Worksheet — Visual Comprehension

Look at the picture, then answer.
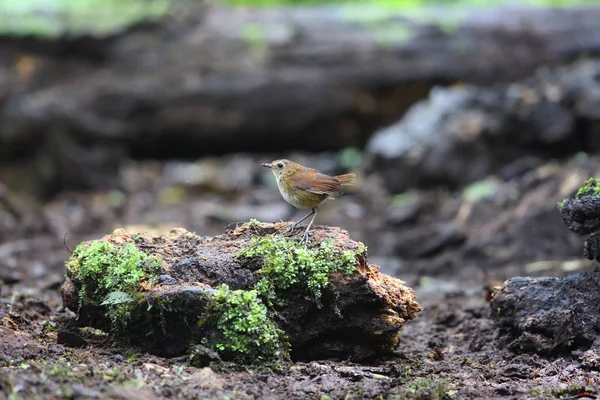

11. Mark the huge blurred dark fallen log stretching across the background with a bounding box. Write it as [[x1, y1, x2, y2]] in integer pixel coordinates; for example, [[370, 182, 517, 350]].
[[0, 5, 600, 195]]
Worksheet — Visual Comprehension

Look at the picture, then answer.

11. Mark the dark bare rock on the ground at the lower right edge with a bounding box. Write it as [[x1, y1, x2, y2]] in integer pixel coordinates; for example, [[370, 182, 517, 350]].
[[490, 268, 600, 355]]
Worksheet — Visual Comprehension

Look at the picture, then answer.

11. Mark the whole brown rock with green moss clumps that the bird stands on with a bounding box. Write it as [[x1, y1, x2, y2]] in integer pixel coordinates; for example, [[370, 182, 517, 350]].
[[62, 221, 421, 363]]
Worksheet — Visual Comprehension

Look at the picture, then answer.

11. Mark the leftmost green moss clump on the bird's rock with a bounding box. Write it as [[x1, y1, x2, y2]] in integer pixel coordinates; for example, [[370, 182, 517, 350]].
[[66, 240, 161, 328]]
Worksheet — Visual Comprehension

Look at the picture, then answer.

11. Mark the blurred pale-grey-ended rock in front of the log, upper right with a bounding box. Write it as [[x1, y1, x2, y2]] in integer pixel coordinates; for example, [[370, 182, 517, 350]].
[[366, 62, 600, 192]]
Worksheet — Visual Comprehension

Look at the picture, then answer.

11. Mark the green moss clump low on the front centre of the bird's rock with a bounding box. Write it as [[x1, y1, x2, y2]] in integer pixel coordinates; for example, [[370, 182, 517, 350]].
[[207, 284, 287, 362]]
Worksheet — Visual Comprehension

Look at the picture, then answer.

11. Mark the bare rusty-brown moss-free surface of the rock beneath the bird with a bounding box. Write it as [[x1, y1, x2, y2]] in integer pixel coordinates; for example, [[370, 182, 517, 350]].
[[62, 222, 421, 359]]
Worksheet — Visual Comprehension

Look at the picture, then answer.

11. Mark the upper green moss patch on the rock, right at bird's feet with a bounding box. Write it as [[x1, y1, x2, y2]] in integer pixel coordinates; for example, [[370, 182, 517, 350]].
[[237, 235, 365, 302]]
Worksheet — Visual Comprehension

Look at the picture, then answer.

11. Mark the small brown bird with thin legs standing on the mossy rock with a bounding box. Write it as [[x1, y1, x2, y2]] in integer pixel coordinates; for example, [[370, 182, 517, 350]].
[[261, 160, 356, 243]]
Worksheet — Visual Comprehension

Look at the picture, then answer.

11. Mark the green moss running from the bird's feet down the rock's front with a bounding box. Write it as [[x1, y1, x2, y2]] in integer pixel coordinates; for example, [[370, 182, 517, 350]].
[[216, 228, 366, 360]]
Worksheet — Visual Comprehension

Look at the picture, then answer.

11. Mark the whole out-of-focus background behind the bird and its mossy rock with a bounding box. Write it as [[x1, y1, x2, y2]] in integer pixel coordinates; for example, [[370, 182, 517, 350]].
[[0, 0, 600, 293]]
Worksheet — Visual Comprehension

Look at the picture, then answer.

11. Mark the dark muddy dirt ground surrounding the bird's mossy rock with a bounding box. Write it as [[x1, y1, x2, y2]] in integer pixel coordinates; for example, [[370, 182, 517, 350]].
[[0, 155, 600, 400]]
